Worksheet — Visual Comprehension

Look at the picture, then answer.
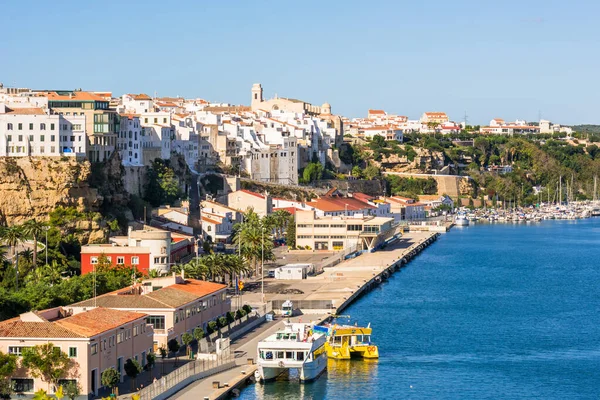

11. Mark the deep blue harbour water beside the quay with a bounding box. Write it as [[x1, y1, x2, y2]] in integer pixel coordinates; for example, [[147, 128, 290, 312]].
[[241, 218, 600, 400]]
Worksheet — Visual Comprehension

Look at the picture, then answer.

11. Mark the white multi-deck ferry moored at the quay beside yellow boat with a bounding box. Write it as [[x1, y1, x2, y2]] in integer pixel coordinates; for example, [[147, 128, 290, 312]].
[[256, 323, 327, 382]]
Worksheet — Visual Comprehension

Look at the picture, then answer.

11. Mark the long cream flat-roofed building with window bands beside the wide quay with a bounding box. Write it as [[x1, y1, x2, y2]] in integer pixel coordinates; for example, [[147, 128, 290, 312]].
[[296, 210, 397, 251]]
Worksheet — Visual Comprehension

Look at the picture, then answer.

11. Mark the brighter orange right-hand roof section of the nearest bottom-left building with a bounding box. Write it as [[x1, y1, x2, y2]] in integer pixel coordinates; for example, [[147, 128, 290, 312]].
[[54, 307, 146, 337]]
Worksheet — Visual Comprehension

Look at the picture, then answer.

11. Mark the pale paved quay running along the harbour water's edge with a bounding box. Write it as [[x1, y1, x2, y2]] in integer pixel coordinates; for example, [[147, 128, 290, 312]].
[[171, 232, 437, 400]]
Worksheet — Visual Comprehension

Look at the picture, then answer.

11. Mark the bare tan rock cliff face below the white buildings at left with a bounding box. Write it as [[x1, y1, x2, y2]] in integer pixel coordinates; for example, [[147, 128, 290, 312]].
[[0, 157, 103, 224]]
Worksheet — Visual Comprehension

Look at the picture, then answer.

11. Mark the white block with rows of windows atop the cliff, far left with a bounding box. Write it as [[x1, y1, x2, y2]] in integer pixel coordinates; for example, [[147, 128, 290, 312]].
[[0, 104, 87, 158]]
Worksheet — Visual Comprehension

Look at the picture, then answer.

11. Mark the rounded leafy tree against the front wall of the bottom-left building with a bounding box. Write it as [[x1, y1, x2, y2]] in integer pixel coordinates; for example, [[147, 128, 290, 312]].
[[21, 343, 72, 385]]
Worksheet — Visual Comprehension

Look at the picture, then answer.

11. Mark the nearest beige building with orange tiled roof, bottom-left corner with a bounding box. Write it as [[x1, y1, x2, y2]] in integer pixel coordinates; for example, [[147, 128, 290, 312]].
[[0, 307, 153, 399]]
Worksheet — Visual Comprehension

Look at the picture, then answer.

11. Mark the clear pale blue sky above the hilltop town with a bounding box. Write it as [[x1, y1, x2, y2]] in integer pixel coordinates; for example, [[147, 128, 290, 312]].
[[0, 0, 600, 124]]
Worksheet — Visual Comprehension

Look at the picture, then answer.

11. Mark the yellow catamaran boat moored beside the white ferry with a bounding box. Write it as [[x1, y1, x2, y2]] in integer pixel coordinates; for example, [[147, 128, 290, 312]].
[[315, 324, 379, 360]]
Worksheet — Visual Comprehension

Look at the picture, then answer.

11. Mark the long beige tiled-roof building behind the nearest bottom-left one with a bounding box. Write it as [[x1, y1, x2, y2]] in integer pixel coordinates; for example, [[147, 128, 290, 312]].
[[68, 274, 231, 351]]
